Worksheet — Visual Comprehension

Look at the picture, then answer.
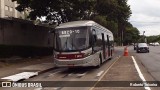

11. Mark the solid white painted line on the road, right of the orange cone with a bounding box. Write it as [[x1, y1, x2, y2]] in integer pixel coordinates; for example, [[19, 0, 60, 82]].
[[132, 56, 151, 90]]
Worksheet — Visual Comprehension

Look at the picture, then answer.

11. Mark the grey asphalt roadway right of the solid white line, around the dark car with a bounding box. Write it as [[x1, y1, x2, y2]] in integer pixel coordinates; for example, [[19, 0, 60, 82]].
[[129, 46, 160, 81]]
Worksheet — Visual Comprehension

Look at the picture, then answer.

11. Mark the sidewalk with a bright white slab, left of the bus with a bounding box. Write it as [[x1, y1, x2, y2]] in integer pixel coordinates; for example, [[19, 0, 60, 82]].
[[0, 56, 54, 81]]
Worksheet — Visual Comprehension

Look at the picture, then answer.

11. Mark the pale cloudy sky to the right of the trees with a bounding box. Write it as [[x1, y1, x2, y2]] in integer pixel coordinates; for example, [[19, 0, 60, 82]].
[[128, 0, 160, 36]]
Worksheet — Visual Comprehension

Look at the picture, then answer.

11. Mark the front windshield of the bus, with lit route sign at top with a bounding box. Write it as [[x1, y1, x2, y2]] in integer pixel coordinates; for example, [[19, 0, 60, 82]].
[[54, 27, 89, 51]]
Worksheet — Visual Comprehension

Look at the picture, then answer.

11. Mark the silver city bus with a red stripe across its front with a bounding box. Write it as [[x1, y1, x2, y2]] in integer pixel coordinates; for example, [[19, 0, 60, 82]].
[[53, 21, 114, 67]]
